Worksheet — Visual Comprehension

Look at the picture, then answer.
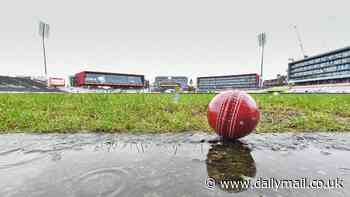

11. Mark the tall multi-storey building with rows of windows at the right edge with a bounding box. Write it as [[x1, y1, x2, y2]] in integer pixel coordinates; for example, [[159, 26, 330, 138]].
[[288, 47, 350, 85]]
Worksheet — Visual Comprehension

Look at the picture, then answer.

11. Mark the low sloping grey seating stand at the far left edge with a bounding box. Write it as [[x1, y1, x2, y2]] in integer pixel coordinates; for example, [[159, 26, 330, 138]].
[[0, 76, 61, 92]]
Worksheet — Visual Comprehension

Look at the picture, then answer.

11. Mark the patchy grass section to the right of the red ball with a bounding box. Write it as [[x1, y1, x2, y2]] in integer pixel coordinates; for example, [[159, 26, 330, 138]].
[[253, 94, 350, 132]]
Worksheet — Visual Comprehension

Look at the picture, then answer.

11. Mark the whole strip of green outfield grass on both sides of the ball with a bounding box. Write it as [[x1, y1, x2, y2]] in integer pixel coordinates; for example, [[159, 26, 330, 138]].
[[0, 93, 350, 133]]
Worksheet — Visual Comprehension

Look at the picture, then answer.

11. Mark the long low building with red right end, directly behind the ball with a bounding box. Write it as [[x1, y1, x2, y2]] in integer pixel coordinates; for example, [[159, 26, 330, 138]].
[[197, 73, 260, 92]]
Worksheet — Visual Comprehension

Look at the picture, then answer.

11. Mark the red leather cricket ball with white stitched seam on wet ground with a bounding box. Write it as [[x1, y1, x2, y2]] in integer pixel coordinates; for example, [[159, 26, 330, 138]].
[[208, 90, 260, 139]]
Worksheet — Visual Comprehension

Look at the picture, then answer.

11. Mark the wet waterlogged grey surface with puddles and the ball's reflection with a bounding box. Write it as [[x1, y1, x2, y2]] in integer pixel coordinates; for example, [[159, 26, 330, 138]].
[[0, 133, 350, 197]]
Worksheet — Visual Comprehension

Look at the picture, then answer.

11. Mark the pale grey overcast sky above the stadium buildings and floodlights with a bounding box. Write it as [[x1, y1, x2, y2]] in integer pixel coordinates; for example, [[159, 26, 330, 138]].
[[0, 0, 350, 79]]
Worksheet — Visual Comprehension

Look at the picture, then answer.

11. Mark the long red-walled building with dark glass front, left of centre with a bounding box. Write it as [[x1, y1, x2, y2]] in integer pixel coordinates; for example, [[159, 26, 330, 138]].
[[74, 71, 145, 89]]
